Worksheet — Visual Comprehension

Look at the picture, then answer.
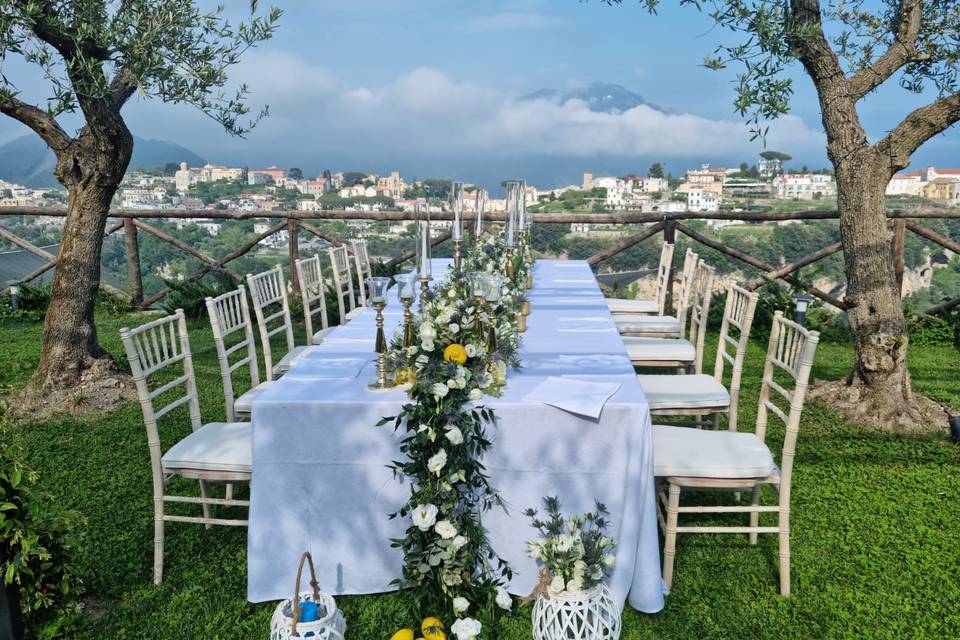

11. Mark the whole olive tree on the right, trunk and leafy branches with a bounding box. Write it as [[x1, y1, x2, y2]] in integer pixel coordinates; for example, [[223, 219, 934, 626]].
[[604, 0, 960, 428]]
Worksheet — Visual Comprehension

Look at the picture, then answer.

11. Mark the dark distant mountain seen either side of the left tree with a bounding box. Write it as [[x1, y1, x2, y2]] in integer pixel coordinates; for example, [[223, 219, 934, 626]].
[[0, 133, 206, 188]]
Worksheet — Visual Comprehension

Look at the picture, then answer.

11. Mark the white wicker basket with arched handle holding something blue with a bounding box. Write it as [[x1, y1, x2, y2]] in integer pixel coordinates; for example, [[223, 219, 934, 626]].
[[270, 551, 347, 640]]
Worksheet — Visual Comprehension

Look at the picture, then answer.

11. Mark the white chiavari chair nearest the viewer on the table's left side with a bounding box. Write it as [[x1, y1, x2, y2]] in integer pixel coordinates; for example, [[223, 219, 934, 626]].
[[120, 309, 251, 584]]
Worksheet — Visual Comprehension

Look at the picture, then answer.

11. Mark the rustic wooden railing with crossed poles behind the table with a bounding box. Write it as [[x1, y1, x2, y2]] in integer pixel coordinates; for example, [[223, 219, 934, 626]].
[[0, 207, 960, 315]]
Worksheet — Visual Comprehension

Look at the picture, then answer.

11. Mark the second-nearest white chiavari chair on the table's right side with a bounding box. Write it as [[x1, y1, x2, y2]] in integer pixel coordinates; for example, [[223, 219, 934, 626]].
[[637, 285, 757, 431]]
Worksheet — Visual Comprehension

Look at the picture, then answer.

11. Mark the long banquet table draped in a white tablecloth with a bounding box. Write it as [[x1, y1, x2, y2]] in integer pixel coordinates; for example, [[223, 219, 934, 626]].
[[247, 260, 664, 613]]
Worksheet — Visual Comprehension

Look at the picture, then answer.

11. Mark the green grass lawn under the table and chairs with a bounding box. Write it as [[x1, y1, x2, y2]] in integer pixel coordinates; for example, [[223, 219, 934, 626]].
[[0, 316, 960, 640]]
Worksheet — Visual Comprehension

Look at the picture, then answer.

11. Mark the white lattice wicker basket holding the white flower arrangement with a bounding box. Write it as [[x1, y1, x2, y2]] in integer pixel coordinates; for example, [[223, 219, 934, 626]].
[[533, 584, 620, 640]]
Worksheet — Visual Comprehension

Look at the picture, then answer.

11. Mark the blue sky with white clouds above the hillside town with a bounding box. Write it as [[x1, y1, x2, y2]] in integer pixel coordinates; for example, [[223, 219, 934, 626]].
[[0, 0, 960, 187]]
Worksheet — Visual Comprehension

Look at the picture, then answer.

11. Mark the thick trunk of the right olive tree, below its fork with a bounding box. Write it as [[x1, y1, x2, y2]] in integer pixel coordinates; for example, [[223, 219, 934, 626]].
[[835, 158, 921, 429]]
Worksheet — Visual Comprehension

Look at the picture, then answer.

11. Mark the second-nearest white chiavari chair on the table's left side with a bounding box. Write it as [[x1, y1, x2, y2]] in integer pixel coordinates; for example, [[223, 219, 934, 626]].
[[206, 285, 273, 421]]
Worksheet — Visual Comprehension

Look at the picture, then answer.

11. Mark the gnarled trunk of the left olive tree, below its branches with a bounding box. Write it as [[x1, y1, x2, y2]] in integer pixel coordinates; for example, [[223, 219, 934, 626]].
[[27, 131, 133, 398]]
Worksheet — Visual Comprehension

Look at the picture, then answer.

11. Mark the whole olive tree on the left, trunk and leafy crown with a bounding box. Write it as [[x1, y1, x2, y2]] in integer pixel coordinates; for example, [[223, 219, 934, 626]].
[[0, 0, 280, 397]]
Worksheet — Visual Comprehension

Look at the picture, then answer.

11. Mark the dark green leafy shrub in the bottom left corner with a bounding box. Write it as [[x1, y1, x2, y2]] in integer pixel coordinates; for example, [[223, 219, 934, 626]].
[[0, 420, 83, 629]]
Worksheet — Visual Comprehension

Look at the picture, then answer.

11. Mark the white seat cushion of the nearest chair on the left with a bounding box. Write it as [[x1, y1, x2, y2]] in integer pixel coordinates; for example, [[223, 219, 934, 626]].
[[161, 422, 251, 473]]
